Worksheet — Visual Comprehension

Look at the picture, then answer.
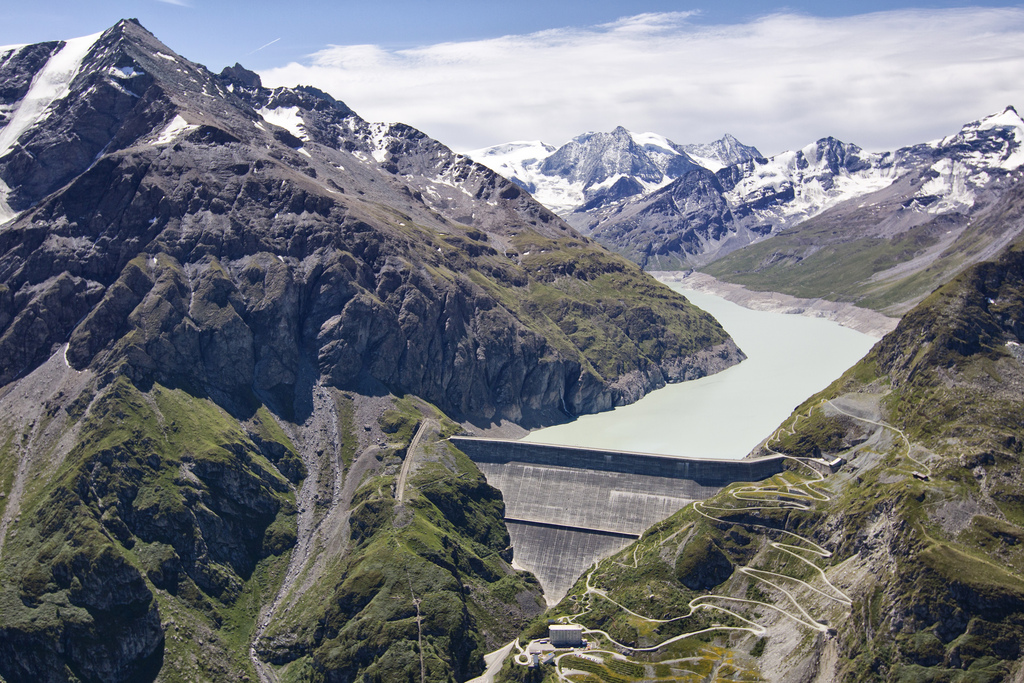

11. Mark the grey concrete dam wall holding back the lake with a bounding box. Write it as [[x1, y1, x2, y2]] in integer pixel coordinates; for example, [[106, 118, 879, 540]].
[[452, 436, 784, 604]]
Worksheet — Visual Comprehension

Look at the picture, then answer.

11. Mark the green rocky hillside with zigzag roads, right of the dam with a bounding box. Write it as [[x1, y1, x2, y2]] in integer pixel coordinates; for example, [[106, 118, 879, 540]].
[[502, 222, 1024, 682]]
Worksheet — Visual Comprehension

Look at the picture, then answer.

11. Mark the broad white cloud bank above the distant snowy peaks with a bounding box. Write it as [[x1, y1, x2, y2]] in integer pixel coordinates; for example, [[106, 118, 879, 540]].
[[261, 8, 1024, 154]]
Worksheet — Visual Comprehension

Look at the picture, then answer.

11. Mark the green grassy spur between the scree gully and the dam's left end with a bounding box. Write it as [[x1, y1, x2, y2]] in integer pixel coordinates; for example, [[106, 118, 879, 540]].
[[265, 397, 541, 681]]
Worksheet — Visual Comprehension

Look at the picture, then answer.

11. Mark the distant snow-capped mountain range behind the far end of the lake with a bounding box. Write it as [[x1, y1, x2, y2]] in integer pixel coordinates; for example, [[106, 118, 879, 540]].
[[470, 106, 1024, 314]]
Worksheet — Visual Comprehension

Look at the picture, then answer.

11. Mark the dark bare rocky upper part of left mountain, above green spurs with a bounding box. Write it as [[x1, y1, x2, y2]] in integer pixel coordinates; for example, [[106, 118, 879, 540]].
[[0, 23, 733, 428]]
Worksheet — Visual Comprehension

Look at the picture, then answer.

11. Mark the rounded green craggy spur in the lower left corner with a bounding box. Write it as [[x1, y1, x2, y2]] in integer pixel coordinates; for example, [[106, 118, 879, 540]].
[[0, 379, 295, 680]]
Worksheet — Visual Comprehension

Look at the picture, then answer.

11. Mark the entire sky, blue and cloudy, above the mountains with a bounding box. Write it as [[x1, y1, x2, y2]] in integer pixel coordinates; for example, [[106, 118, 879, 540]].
[[6, 0, 1024, 154]]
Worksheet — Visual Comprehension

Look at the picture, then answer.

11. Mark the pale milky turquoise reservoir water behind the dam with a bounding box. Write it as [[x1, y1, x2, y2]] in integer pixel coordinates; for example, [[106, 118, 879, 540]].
[[523, 286, 877, 459]]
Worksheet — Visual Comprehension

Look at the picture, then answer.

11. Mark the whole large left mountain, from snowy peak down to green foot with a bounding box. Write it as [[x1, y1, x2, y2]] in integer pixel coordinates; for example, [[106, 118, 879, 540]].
[[0, 20, 741, 682]]
